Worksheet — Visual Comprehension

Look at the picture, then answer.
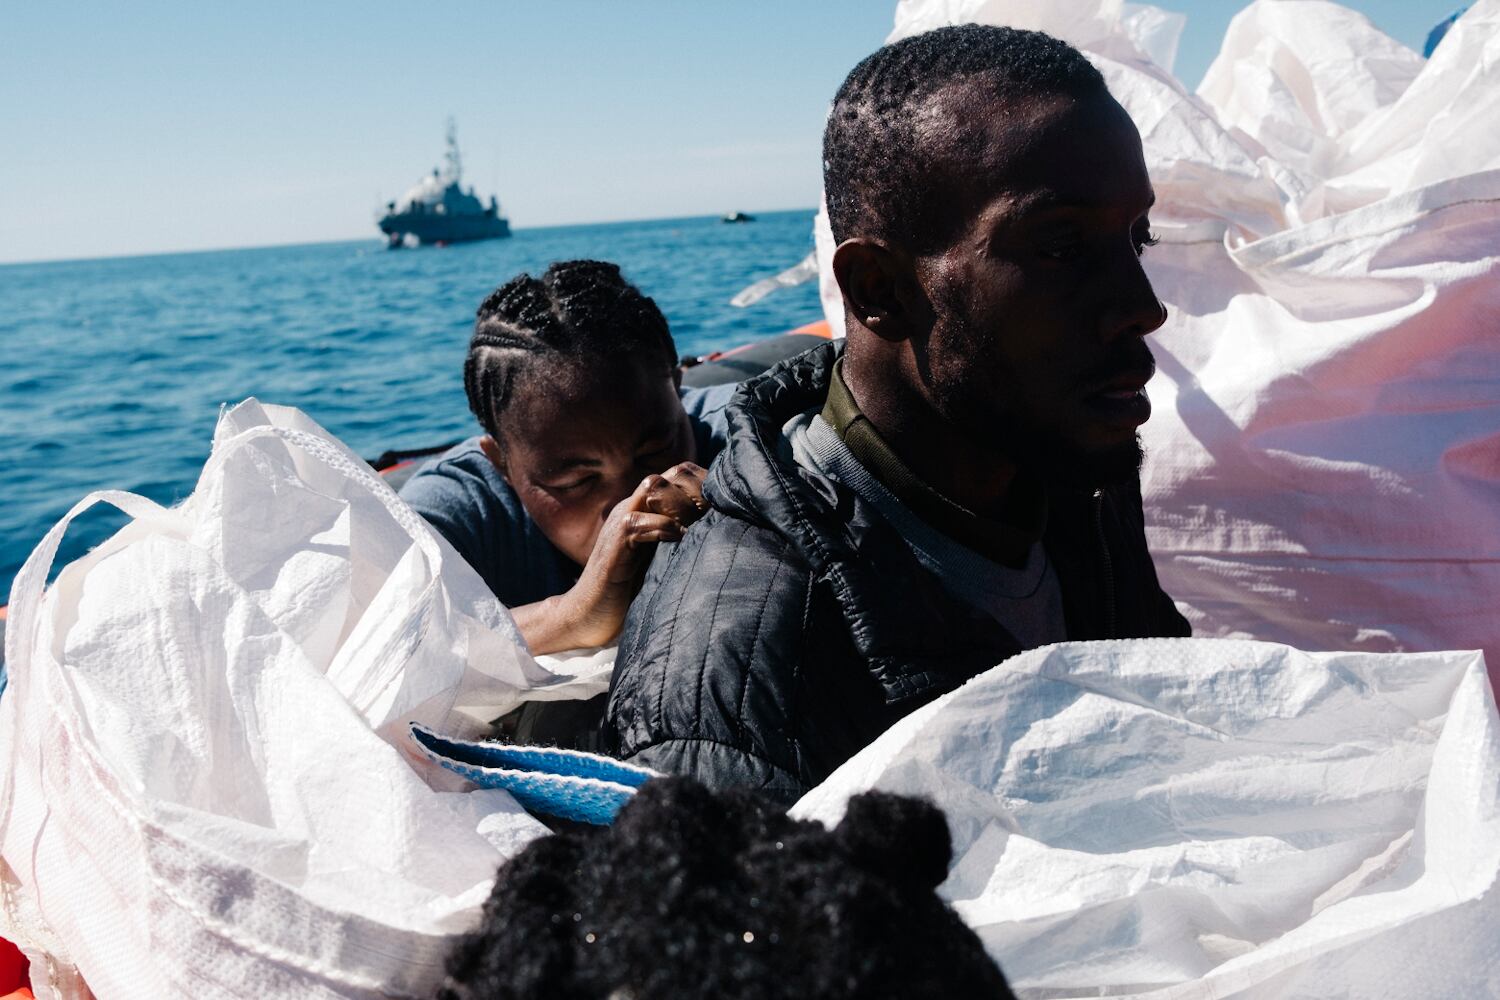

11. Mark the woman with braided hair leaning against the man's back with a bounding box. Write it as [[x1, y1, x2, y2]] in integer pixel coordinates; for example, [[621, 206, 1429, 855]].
[[401, 261, 734, 654]]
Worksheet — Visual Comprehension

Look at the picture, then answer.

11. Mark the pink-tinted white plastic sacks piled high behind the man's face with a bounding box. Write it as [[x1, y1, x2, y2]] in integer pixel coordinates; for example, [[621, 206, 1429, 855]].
[[819, 0, 1500, 692]]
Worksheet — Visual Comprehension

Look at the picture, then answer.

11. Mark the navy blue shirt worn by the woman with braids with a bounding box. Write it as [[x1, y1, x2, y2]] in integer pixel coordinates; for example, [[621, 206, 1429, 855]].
[[401, 384, 738, 607]]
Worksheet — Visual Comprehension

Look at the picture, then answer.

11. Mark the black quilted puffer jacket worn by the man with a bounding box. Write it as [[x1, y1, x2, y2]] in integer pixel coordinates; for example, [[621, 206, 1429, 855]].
[[603, 345, 1188, 802]]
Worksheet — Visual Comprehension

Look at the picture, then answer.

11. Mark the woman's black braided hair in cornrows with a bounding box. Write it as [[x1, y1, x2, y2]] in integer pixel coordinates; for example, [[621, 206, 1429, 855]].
[[464, 261, 677, 441]]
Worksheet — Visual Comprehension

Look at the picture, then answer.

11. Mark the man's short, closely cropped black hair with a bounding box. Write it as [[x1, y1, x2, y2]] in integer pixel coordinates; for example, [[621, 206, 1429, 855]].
[[824, 24, 1109, 250]]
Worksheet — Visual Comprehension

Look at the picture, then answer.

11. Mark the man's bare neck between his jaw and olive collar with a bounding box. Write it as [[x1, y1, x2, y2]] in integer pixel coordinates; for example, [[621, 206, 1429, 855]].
[[842, 347, 1017, 517]]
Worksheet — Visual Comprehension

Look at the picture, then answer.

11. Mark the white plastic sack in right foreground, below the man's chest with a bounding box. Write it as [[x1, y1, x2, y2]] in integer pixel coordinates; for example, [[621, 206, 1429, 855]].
[[792, 639, 1500, 1000]]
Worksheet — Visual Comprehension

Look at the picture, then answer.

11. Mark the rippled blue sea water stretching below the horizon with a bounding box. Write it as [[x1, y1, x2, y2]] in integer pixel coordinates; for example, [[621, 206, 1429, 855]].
[[0, 211, 821, 590]]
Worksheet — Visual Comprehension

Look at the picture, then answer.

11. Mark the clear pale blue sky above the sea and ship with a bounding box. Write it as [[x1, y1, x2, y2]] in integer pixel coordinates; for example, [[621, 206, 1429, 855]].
[[0, 0, 1458, 261]]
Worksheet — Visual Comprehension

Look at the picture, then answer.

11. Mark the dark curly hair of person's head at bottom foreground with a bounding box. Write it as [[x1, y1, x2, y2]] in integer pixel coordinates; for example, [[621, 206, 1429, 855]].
[[440, 778, 1013, 1000]]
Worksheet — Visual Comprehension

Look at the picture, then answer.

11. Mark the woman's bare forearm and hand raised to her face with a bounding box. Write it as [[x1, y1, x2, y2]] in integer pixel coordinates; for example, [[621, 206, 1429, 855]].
[[512, 462, 708, 654]]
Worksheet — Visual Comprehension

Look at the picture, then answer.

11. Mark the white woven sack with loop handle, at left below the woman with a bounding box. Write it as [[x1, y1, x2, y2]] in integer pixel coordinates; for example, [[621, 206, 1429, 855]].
[[0, 400, 558, 1000]]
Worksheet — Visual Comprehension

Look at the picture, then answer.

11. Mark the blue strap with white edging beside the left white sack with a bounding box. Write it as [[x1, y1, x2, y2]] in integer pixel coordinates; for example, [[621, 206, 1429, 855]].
[[411, 723, 660, 826]]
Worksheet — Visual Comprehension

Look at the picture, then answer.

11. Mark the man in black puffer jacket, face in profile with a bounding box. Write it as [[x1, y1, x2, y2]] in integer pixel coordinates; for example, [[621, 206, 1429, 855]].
[[603, 25, 1188, 801]]
